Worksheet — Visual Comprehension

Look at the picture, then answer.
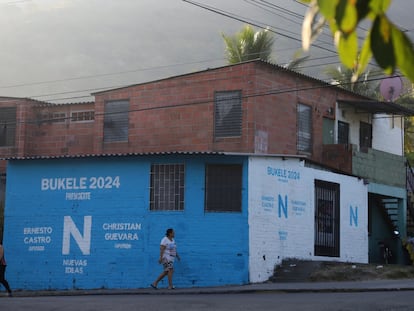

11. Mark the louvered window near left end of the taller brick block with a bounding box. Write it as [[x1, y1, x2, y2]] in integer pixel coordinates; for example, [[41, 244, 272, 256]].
[[104, 100, 129, 142]]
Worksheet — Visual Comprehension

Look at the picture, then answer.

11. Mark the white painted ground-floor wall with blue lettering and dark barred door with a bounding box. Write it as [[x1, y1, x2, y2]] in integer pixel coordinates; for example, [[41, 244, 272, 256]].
[[248, 157, 368, 282]]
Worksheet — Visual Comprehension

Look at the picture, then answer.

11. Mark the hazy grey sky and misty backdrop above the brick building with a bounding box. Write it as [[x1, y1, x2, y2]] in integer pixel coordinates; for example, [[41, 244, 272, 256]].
[[0, 0, 414, 102]]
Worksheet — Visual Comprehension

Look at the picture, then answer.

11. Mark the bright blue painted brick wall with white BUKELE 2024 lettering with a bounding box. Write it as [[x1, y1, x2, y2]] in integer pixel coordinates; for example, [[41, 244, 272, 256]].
[[4, 156, 249, 290]]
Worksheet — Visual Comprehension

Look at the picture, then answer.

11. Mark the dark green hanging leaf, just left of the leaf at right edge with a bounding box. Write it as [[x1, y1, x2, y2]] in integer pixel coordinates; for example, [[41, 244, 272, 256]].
[[370, 15, 396, 74]]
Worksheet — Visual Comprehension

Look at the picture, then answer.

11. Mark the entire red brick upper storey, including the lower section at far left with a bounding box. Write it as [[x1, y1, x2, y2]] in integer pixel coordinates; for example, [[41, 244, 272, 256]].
[[0, 61, 382, 169]]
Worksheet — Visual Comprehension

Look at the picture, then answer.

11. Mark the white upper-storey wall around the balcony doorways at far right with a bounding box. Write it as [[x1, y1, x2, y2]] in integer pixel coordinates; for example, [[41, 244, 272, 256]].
[[335, 107, 404, 156]]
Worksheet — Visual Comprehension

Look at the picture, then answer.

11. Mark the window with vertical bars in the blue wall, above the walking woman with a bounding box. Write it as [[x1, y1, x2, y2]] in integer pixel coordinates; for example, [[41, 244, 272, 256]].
[[150, 164, 184, 211]]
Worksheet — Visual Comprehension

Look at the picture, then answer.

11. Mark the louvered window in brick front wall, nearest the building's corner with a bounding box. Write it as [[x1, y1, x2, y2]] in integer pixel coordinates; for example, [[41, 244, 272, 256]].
[[214, 91, 242, 138]]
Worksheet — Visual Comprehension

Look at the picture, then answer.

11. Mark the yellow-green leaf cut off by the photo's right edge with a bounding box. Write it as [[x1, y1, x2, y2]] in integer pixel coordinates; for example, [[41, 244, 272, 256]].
[[392, 25, 414, 82]]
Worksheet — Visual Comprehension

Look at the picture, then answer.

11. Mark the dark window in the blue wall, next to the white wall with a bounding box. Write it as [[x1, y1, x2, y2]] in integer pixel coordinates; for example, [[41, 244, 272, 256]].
[[205, 164, 242, 212]]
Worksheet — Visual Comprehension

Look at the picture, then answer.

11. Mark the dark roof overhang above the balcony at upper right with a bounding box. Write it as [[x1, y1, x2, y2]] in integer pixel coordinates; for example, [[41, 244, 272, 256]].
[[338, 100, 414, 116]]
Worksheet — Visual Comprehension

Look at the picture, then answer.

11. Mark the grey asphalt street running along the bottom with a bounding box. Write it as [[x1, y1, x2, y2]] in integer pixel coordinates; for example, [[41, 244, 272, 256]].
[[0, 290, 414, 311]]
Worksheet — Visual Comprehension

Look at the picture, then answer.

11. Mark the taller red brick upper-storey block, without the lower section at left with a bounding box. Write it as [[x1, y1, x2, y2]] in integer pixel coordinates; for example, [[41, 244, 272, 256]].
[[94, 62, 362, 161]]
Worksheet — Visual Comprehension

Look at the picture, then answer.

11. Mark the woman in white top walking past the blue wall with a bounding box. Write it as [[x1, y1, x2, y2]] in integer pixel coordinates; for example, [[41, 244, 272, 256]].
[[151, 228, 180, 289]]
